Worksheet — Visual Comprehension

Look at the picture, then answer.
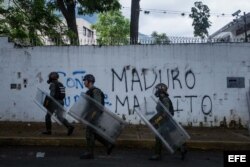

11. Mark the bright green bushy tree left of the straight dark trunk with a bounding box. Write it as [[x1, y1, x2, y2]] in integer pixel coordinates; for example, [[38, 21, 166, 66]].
[[92, 10, 129, 45]]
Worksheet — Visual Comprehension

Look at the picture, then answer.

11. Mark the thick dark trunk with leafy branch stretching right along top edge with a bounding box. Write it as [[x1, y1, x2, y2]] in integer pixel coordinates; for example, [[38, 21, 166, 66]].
[[52, 0, 121, 44]]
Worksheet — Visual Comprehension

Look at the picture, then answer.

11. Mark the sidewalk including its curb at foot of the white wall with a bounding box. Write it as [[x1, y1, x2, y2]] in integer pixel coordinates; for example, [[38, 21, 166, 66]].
[[0, 122, 250, 150]]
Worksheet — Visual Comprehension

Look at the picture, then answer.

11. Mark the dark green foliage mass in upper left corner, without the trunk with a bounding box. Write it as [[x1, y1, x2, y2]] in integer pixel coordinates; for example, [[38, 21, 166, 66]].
[[0, 0, 66, 45]]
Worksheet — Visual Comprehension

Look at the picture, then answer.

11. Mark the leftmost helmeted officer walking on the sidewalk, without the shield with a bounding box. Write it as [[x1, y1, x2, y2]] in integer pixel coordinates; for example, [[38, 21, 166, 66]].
[[42, 72, 74, 136]]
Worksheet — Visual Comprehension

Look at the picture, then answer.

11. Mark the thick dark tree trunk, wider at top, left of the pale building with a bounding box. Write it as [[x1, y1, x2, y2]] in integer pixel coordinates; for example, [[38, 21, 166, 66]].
[[57, 0, 79, 45]]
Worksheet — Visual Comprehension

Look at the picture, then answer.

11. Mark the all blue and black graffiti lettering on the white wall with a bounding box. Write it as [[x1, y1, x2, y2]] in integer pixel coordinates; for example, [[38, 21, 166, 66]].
[[55, 67, 212, 118]]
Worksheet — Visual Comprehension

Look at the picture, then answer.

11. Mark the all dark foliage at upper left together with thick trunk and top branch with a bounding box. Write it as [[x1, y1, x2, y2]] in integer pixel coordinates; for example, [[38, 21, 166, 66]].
[[0, 0, 121, 45]]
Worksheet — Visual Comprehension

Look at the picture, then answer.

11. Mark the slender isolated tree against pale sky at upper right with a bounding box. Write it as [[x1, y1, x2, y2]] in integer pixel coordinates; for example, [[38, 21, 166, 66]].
[[189, 1, 211, 38]]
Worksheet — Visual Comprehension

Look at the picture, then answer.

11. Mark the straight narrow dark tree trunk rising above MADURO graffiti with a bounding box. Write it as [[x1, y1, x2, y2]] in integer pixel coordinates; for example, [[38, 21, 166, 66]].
[[130, 0, 140, 44]]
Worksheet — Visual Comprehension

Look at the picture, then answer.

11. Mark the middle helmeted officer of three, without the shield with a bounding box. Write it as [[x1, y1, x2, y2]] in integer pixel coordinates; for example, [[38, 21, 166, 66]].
[[80, 74, 114, 159]]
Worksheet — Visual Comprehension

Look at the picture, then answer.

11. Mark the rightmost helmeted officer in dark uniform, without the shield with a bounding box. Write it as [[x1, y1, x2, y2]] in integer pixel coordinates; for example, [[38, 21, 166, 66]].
[[149, 83, 187, 161]]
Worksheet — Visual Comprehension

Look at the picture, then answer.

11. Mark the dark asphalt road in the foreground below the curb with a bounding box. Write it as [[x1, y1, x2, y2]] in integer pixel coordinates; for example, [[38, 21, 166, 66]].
[[0, 146, 223, 167]]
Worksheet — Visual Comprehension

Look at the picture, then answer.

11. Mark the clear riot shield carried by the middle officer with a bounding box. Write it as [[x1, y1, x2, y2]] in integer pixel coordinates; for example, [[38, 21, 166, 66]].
[[68, 93, 126, 144]]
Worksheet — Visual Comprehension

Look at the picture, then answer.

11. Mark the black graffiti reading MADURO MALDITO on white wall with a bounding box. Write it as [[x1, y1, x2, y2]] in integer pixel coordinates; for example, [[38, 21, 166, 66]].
[[111, 67, 212, 115]]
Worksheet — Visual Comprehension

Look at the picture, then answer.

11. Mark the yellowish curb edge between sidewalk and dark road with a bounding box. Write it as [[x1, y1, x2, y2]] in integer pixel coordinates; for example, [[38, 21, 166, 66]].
[[0, 137, 250, 151]]
